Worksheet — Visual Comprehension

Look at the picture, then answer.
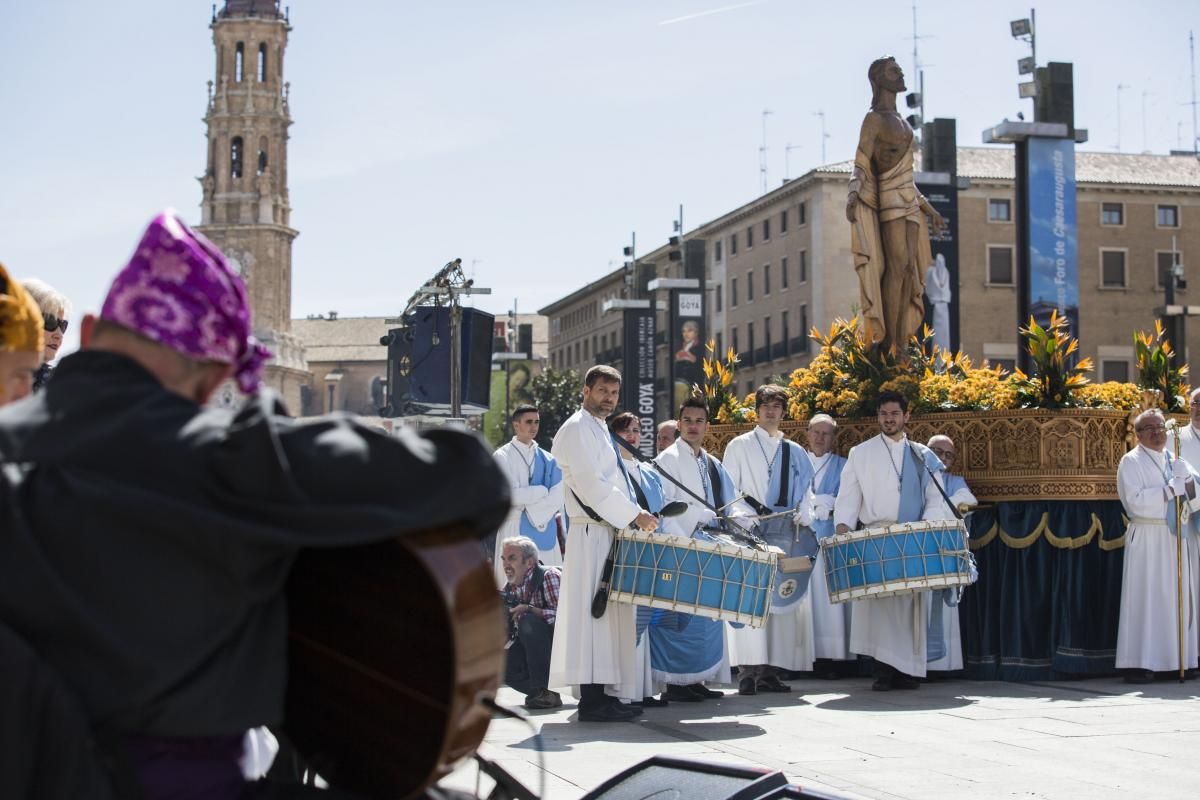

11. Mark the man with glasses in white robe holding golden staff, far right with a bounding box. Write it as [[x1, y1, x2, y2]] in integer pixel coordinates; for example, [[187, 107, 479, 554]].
[[1116, 409, 1200, 684]]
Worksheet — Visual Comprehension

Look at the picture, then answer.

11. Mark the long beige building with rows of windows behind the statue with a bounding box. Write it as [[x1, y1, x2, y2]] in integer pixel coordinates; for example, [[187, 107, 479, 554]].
[[541, 148, 1200, 416]]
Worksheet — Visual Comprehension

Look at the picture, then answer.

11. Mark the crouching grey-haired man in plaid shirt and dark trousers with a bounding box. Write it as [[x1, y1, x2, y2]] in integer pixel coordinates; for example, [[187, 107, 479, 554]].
[[500, 536, 563, 709]]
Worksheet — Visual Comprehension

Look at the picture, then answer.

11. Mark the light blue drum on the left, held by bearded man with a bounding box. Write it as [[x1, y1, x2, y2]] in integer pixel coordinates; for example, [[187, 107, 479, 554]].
[[608, 529, 776, 627]]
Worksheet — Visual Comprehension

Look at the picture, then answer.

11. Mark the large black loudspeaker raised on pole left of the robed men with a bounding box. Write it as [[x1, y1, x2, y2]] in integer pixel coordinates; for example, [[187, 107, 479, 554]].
[[380, 306, 496, 416]]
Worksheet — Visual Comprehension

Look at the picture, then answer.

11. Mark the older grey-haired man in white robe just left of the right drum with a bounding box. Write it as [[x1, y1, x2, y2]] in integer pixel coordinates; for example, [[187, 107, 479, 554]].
[[808, 414, 854, 680]]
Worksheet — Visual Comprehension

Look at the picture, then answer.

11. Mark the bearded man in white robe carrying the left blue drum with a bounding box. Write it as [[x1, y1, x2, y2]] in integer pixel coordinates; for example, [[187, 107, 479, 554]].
[[550, 365, 659, 722]]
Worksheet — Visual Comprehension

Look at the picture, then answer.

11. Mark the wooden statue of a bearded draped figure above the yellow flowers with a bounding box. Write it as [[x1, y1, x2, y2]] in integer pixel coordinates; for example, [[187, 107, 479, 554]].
[[846, 55, 944, 357]]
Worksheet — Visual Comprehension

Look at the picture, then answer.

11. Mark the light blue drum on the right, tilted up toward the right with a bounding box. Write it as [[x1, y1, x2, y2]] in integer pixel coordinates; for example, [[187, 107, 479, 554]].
[[821, 519, 976, 603]]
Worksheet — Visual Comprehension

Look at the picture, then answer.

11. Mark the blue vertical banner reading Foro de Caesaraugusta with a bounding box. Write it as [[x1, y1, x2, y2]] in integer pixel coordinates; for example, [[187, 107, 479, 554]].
[[1021, 137, 1079, 338]]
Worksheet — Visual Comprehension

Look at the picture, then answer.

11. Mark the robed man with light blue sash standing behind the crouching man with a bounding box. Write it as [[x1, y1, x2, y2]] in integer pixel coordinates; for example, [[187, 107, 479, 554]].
[[492, 403, 563, 589]]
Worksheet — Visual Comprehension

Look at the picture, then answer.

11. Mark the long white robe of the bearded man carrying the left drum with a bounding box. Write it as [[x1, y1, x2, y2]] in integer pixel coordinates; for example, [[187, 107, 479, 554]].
[[550, 409, 643, 699]]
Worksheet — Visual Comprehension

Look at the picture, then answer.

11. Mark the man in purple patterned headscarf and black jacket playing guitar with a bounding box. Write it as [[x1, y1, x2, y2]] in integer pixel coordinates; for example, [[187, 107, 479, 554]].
[[0, 212, 509, 800]]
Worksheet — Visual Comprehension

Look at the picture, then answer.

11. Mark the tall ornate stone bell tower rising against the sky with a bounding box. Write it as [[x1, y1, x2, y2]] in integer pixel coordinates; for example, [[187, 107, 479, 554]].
[[197, 0, 310, 402]]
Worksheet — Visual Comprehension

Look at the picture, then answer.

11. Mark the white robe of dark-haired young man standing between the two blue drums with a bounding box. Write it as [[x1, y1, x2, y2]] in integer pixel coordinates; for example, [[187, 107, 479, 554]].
[[722, 426, 814, 672]]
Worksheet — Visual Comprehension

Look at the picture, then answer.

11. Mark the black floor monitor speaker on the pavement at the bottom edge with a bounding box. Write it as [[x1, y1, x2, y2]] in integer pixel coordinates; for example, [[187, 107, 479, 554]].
[[583, 756, 787, 800]]
